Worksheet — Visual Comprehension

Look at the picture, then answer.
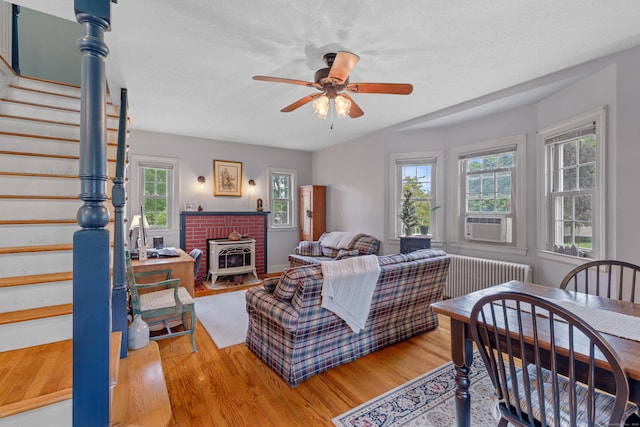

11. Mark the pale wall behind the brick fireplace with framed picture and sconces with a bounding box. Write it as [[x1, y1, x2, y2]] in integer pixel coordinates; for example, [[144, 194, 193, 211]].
[[127, 129, 312, 272]]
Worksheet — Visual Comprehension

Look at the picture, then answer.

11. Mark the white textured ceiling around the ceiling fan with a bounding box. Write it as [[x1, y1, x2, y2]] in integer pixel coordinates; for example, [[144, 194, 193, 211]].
[[15, 0, 640, 151]]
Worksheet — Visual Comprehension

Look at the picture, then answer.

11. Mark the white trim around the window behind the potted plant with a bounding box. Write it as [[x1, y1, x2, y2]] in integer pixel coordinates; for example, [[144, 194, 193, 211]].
[[386, 151, 446, 243]]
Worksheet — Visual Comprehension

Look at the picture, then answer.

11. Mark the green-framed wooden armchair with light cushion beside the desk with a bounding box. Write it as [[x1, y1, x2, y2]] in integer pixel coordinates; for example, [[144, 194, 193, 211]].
[[126, 252, 197, 352]]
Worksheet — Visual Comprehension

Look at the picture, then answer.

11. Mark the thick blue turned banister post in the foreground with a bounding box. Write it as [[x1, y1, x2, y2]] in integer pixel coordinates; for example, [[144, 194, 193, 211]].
[[72, 0, 111, 427]]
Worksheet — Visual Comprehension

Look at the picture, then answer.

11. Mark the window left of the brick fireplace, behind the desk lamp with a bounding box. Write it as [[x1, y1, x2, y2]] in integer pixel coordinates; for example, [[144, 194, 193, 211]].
[[130, 156, 177, 230]]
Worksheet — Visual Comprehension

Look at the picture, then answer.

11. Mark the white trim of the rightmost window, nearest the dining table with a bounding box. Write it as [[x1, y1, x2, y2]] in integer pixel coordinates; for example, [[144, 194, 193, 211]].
[[536, 106, 607, 265]]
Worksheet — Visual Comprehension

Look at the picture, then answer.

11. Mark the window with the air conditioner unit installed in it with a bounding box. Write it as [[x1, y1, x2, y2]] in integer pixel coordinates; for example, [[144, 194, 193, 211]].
[[453, 135, 526, 250]]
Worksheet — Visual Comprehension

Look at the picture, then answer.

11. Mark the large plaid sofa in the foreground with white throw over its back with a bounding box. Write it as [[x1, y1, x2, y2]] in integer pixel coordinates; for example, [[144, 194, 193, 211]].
[[246, 249, 449, 386]]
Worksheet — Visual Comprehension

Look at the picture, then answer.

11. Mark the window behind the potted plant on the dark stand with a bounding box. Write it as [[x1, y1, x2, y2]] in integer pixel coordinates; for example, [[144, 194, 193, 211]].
[[390, 153, 444, 238]]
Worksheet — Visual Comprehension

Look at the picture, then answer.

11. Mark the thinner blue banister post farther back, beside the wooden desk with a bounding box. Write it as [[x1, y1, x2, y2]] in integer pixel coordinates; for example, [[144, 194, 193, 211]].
[[111, 89, 128, 358]]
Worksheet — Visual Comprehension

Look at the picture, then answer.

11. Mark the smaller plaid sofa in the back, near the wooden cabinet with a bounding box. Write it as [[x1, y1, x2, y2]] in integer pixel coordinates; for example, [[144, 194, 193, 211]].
[[289, 233, 380, 267]]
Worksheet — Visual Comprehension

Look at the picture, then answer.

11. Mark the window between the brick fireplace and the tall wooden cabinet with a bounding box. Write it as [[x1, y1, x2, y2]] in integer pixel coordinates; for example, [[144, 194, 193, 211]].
[[269, 169, 297, 228]]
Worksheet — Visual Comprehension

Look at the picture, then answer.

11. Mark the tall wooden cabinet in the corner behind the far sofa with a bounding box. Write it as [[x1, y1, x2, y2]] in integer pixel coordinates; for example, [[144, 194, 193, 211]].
[[300, 185, 327, 241]]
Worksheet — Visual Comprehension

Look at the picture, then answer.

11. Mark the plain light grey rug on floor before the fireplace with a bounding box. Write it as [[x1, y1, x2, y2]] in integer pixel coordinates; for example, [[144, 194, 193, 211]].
[[195, 289, 249, 348]]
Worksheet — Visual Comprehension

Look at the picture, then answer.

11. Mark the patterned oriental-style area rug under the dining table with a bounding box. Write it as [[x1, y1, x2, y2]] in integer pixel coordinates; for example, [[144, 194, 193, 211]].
[[332, 352, 498, 427]]
